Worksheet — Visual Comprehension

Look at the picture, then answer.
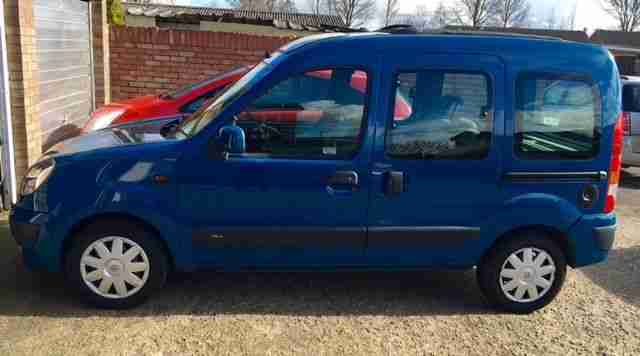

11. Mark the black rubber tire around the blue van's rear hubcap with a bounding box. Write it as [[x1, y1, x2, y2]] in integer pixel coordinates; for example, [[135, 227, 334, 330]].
[[476, 232, 567, 314]]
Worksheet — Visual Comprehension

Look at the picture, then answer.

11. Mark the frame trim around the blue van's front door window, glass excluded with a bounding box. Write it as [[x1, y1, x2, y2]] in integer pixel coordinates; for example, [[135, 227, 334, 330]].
[[221, 65, 374, 162]]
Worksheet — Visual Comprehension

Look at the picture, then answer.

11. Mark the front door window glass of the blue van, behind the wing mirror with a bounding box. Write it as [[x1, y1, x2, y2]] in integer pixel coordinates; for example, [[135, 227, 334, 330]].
[[236, 69, 368, 159]]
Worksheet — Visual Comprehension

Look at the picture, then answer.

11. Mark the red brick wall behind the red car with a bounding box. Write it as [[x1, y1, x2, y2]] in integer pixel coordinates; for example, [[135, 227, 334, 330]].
[[109, 26, 293, 101]]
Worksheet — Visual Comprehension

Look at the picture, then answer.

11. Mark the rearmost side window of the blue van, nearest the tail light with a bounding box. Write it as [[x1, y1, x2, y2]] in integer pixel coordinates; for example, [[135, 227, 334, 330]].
[[515, 73, 601, 159]]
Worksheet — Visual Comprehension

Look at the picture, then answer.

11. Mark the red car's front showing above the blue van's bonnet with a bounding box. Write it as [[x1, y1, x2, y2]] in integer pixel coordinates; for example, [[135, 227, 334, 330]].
[[82, 66, 251, 132]]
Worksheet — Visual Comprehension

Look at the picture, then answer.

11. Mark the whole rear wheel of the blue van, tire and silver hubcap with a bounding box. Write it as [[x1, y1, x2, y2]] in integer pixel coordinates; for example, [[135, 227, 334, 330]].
[[477, 232, 567, 314]]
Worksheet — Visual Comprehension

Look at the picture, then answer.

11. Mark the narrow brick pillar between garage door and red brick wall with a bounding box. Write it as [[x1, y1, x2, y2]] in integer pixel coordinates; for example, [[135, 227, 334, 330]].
[[90, 0, 111, 108]]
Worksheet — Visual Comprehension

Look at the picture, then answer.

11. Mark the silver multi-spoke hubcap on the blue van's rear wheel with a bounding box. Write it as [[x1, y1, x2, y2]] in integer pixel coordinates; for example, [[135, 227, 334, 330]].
[[499, 247, 556, 303]]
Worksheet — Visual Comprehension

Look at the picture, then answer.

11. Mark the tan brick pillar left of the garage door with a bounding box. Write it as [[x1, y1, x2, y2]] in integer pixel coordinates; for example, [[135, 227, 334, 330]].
[[4, 0, 42, 180]]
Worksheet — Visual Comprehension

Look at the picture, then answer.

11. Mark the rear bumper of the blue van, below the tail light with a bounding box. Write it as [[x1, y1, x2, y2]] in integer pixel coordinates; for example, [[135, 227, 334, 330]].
[[568, 214, 617, 268]]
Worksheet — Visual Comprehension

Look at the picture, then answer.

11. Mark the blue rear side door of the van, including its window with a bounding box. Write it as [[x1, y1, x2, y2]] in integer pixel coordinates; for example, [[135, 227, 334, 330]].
[[367, 54, 504, 266]]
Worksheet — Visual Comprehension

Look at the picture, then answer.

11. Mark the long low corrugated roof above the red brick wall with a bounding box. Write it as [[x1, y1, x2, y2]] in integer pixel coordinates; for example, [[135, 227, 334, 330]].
[[124, 2, 344, 31]]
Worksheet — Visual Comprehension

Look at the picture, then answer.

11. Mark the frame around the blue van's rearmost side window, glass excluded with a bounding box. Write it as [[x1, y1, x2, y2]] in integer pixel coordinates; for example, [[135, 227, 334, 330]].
[[510, 71, 604, 162]]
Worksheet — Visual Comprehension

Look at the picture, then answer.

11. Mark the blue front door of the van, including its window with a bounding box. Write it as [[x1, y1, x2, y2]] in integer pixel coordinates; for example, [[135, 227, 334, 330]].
[[179, 66, 372, 268]]
